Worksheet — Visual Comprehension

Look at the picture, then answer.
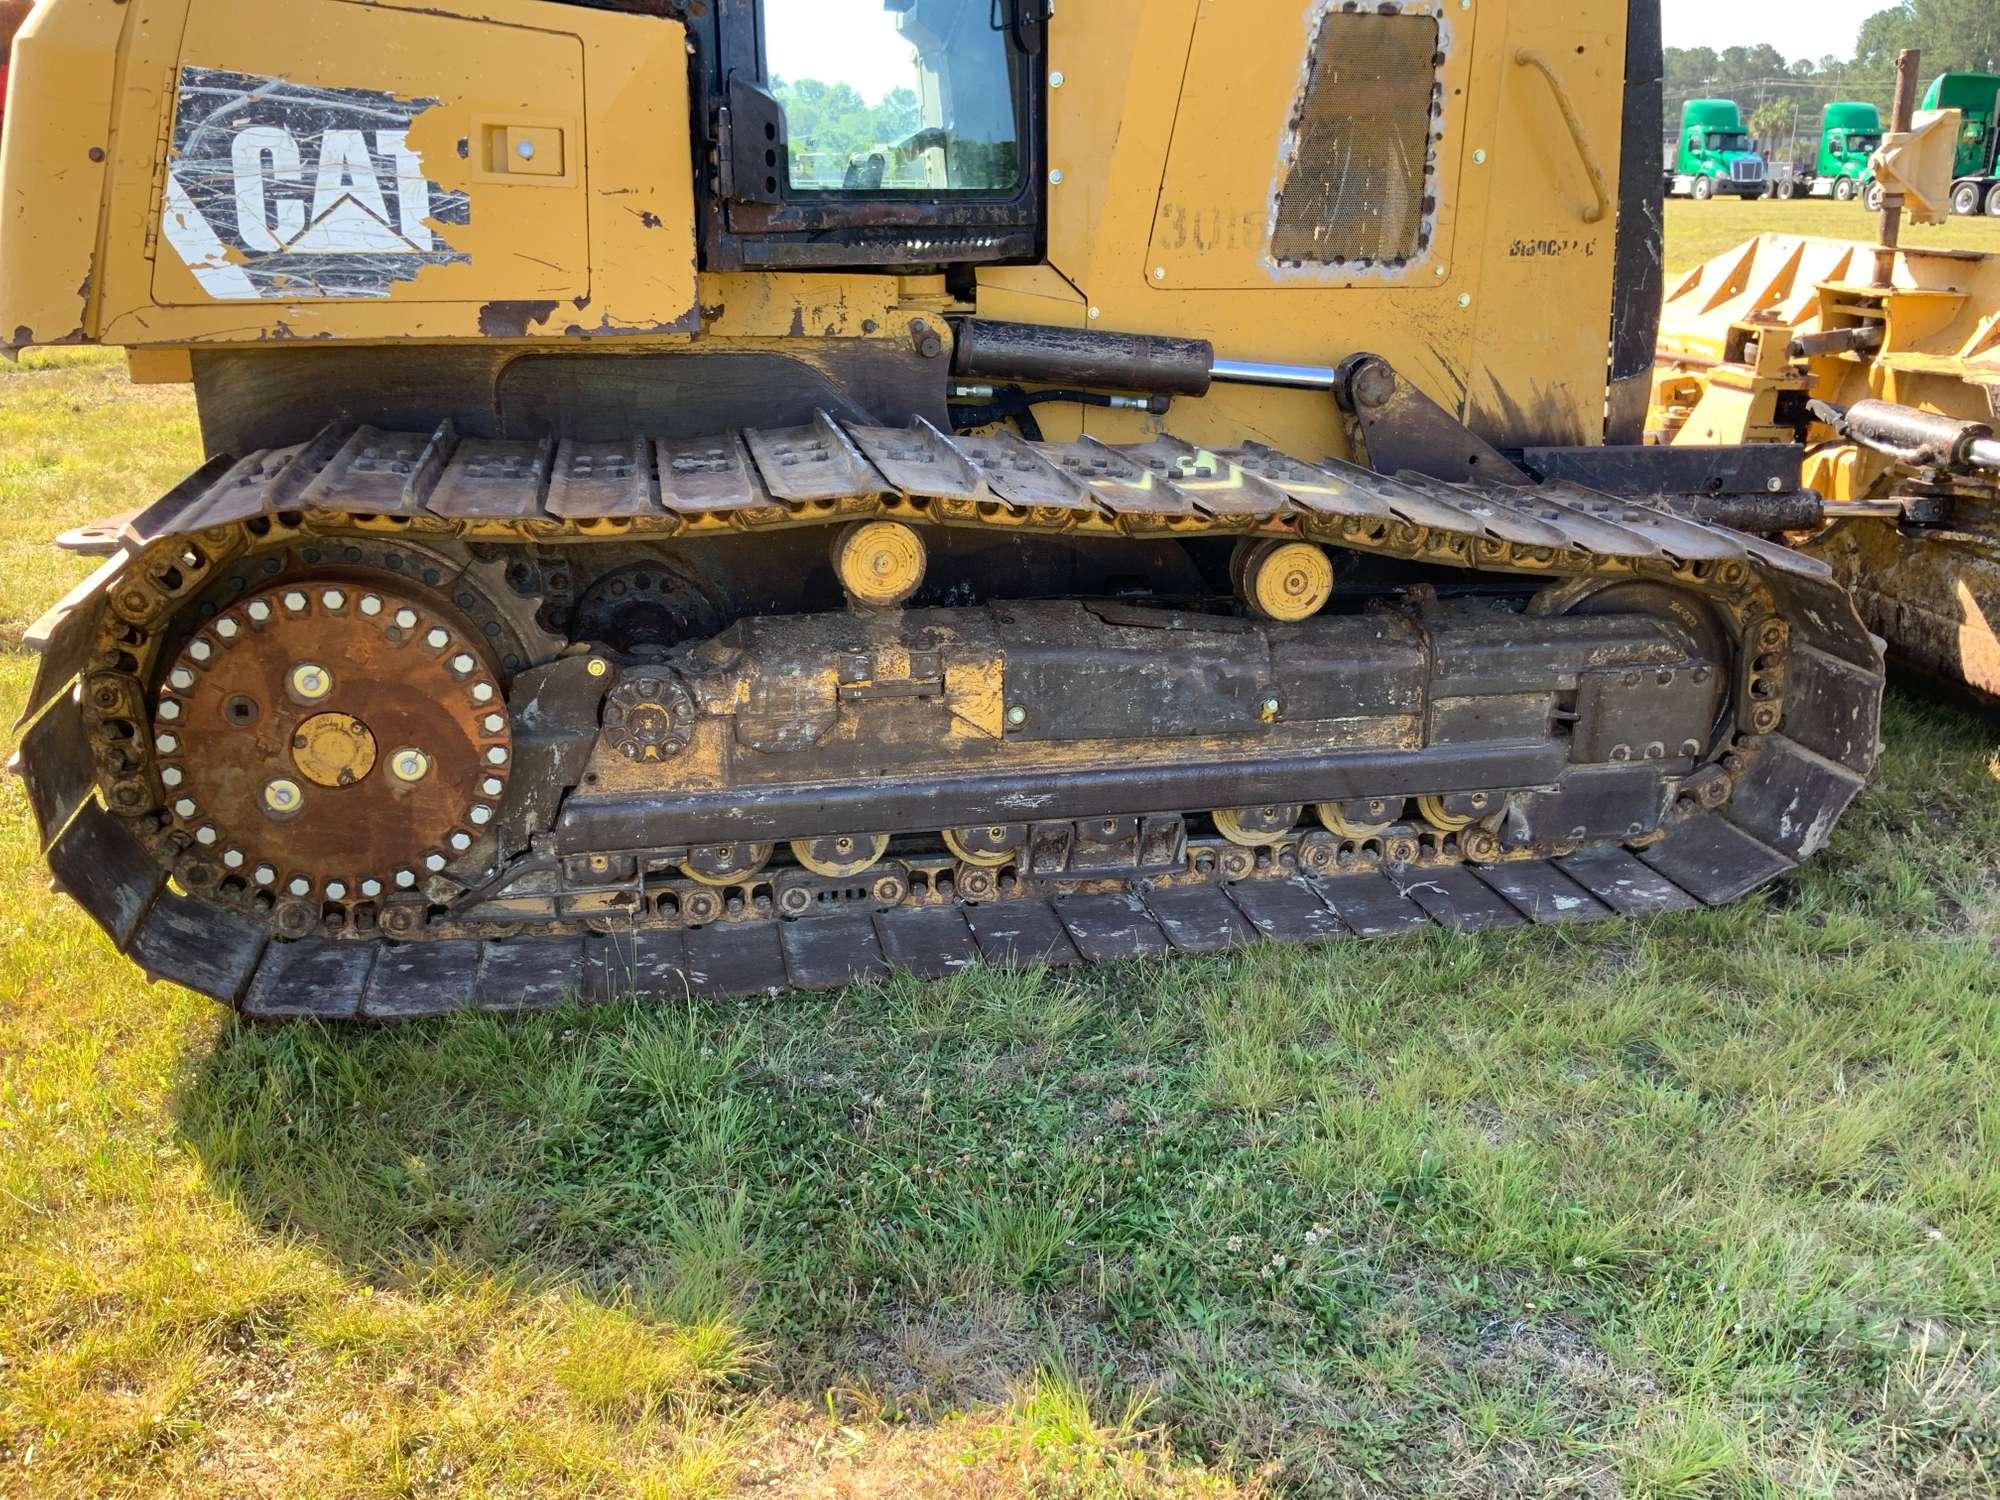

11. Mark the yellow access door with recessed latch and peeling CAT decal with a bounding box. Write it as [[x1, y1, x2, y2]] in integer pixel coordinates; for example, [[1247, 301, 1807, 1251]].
[[152, 0, 590, 308]]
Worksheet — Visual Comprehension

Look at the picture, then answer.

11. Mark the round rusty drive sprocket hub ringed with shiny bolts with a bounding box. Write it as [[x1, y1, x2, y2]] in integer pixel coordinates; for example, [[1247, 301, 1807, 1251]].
[[152, 578, 514, 908]]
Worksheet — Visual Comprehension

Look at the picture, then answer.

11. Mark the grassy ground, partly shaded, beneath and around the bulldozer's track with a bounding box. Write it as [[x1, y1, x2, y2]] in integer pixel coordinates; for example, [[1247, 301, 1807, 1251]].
[[0, 214, 2000, 1498]]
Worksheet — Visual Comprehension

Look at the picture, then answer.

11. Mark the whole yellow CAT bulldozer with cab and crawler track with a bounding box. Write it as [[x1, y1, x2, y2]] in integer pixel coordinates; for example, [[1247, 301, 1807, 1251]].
[[0, 0, 1884, 1018]]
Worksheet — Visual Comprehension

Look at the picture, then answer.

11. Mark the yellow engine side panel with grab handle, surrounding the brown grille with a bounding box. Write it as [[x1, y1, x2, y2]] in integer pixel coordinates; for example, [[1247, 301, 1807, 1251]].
[[1040, 0, 1626, 454]]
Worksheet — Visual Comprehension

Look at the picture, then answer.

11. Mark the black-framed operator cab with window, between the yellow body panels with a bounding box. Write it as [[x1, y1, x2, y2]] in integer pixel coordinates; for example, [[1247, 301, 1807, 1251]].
[[688, 0, 1044, 270]]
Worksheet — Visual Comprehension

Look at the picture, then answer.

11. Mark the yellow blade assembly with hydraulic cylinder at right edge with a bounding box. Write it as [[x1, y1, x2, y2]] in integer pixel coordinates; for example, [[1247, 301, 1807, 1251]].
[[1650, 236, 2000, 708]]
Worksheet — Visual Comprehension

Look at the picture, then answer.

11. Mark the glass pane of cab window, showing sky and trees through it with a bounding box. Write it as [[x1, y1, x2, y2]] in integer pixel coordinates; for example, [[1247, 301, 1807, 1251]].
[[762, 0, 1022, 196]]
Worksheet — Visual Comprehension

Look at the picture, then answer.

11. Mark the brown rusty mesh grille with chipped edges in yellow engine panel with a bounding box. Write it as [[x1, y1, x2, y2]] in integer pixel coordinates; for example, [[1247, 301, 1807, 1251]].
[[1270, 12, 1440, 266]]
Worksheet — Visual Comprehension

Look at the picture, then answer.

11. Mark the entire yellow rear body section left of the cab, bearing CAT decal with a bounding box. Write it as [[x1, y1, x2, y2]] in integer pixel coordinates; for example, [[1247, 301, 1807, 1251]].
[[0, 0, 696, 348]]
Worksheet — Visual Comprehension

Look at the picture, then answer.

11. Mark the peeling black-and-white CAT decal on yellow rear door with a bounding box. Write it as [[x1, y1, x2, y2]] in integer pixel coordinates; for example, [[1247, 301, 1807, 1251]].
[[160, 68, 472, 302]]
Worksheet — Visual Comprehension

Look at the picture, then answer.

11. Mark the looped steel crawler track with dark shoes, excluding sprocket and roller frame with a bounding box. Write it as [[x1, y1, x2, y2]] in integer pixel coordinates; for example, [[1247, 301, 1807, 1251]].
[[18, 416, 1882, 1018]]
